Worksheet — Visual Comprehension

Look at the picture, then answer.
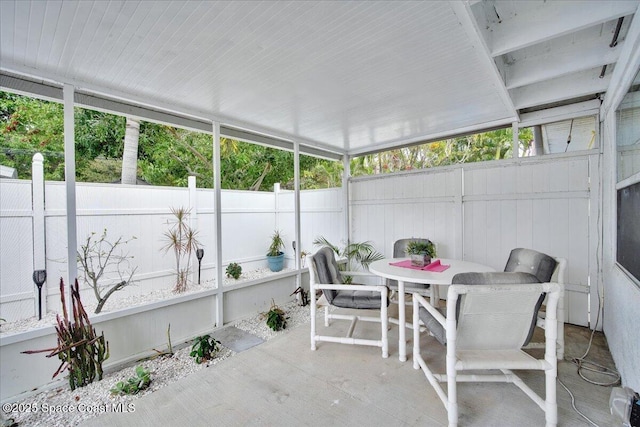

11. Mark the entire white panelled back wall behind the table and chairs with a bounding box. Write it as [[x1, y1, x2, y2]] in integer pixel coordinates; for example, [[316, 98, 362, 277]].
[[350, 154, 599, 325]]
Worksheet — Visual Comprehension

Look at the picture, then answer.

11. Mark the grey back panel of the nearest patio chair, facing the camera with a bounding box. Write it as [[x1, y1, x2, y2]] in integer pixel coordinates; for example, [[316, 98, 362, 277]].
[[447, 283, 557, 350]]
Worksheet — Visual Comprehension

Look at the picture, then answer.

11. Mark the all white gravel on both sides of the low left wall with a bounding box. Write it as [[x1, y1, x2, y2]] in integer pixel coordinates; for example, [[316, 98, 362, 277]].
[[0, 268, 310, 426]]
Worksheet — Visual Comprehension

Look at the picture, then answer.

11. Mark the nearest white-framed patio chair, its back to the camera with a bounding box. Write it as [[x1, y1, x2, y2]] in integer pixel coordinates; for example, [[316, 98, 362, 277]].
[[413, 272, 562, 426]]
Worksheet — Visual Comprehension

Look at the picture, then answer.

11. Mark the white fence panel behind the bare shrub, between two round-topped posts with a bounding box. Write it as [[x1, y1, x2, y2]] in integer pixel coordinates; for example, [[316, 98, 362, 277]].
[[40, 182, 189, 310]]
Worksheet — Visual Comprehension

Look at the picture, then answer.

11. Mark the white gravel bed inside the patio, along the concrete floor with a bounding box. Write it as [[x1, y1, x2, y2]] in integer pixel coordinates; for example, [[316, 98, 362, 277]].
[[2, 301, 310, 426]]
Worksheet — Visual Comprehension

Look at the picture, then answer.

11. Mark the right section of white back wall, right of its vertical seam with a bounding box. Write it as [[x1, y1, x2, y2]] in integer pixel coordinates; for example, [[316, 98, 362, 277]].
[[463, 156, 598, 325]]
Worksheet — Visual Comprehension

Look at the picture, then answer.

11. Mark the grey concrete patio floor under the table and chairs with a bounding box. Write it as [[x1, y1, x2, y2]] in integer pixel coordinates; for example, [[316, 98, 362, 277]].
[[84, 306, 615, 426]]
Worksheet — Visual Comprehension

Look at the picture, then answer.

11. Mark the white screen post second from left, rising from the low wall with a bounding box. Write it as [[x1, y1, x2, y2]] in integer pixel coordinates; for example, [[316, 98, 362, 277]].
[[213, 122, 224, 328]]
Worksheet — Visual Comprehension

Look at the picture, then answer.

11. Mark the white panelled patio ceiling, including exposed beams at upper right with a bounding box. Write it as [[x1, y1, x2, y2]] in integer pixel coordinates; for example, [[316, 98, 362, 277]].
[[0, 0, 640, 154]]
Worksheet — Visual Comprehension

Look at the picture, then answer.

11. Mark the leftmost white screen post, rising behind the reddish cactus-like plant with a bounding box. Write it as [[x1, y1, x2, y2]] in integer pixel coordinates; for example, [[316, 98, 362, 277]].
[[62, 84, 78, 313]]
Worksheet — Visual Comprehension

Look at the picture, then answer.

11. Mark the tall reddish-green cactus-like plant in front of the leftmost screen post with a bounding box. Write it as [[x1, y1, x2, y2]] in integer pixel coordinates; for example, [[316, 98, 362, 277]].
[[23, 278, 109, 390]]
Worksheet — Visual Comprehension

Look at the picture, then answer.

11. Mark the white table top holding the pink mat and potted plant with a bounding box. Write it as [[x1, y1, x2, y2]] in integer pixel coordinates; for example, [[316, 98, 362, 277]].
[[369, 258, 495, 285]]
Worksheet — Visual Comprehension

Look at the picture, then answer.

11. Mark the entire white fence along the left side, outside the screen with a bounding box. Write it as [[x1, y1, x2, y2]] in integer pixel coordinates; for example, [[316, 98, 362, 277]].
[[0, 179, 344, 321]]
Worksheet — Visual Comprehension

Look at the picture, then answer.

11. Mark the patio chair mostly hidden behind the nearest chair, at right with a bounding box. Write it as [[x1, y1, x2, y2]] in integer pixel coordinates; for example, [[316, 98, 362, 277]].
[[504, 248, 567, 360]]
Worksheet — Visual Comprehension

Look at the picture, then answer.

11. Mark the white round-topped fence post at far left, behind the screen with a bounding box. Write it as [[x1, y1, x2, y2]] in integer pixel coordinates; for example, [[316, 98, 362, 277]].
[[31, 153, 48, 316]]
